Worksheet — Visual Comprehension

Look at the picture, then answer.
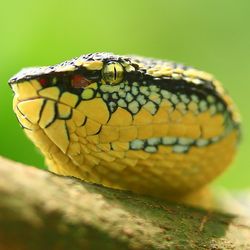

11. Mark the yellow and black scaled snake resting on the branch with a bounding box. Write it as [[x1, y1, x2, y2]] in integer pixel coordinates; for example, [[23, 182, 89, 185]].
[[9, 52, 241, 206]]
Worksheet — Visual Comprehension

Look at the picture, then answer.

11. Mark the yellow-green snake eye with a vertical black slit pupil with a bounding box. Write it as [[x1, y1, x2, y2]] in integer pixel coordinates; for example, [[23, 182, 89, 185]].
[[102, 62, 124, 84]]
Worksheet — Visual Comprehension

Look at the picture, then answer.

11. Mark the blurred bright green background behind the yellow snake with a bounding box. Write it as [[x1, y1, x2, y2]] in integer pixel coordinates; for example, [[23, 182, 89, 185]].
[[0, 0, 250, 189]]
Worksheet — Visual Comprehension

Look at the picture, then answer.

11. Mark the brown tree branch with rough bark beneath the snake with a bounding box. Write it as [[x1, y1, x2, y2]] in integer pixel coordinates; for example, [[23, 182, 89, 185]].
[[0, 158, 250, 250]]
